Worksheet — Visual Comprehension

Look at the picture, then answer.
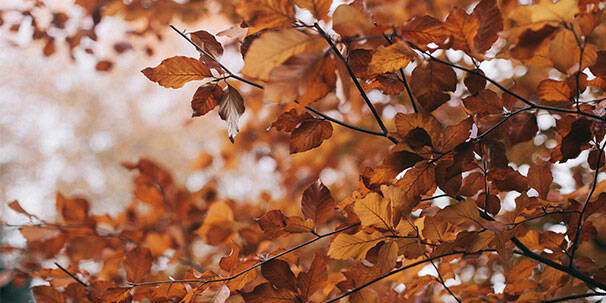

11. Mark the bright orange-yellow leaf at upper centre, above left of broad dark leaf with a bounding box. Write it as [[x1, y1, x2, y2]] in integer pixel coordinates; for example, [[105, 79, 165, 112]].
[[368, 41, 416, 74]]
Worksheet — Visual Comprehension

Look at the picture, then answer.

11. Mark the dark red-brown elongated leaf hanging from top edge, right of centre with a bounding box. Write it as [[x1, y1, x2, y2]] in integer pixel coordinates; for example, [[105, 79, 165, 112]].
[[473, 0, 503, 53]]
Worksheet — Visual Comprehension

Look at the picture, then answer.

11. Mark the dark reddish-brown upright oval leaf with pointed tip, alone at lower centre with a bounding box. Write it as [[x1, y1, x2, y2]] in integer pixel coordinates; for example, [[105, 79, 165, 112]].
[[301, 180, 335, 226]]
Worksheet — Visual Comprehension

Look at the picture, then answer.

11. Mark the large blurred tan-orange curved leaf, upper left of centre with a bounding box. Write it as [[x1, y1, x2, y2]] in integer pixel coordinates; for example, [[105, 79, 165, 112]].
[[242, 29, 325, 80]]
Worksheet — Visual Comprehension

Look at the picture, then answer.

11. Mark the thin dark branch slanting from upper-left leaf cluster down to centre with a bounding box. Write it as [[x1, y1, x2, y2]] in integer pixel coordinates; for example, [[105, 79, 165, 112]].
[[170, 25, 399, 144]]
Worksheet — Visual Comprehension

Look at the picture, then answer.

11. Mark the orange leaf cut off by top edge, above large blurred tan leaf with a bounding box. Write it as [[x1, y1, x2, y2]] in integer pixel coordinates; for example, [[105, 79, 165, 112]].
[[236, 0, 295, 35]]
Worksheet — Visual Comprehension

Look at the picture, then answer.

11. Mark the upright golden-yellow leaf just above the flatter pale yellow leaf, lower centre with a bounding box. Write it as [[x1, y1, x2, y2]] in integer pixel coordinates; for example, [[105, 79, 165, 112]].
[[354, 193, 393, 230]]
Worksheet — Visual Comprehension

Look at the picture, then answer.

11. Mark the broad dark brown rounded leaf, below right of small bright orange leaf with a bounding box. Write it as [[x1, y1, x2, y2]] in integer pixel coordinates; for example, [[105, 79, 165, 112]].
[[410, 60, 458, 112]]
